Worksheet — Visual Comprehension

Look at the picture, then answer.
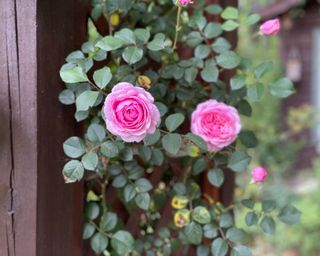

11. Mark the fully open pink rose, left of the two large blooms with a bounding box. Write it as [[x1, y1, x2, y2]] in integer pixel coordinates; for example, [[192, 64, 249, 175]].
[[103, 83, 160, 142]]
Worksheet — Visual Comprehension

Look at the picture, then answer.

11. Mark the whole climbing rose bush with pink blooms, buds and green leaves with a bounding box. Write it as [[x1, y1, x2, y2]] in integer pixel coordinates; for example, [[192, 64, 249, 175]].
[[59, 0, 300, 256]]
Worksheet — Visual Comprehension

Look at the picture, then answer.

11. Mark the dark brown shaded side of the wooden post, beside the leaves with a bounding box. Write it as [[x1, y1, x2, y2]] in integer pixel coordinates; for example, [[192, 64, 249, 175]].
[[37, 0, 90, 256]]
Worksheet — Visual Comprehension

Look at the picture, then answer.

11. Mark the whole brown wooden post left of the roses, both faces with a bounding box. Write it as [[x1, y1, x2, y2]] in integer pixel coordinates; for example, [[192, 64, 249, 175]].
[[0, 0, 88, 256]]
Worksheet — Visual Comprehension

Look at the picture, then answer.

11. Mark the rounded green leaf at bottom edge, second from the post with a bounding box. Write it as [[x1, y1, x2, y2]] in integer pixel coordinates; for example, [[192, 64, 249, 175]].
[[111, 231, 134, 255]]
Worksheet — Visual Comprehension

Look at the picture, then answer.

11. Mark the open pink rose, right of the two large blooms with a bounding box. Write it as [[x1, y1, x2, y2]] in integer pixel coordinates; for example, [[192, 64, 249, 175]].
[[191, 100, 241, 152]]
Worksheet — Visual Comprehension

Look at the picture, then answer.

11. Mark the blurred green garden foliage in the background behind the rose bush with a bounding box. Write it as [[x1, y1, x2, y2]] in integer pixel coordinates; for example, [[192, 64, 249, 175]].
[[236, 0, 320, 256]]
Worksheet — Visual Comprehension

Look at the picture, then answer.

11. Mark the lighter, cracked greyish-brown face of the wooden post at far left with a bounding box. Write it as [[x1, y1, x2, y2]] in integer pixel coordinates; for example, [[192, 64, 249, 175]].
[[0, 0, 37, 255]]
